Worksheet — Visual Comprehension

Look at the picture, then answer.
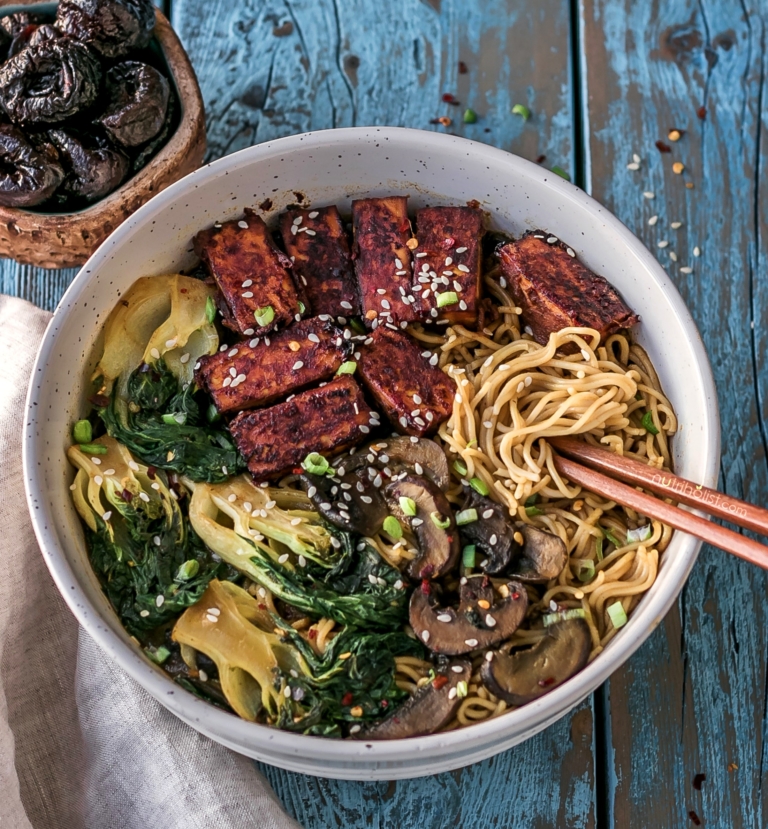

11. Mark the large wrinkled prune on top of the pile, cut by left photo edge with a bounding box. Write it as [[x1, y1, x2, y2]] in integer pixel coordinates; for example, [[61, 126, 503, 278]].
[[0, 38, 101, 125]]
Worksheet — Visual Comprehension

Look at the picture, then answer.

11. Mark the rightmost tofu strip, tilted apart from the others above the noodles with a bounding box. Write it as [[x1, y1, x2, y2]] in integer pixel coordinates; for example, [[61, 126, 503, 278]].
[[498, 230, 640, 350]]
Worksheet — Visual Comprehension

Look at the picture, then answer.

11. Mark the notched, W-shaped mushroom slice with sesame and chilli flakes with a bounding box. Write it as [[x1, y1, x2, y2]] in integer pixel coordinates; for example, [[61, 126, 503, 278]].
[[409, 576, 528, 656]]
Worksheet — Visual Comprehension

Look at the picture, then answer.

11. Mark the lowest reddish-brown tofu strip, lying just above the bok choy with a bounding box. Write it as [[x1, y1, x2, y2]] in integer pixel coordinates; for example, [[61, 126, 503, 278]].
[[229, 374, 378, 481]]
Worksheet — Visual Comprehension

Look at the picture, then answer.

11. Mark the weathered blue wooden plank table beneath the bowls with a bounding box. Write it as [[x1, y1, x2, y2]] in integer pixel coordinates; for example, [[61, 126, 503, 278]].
[[7, 0, 768, 829]]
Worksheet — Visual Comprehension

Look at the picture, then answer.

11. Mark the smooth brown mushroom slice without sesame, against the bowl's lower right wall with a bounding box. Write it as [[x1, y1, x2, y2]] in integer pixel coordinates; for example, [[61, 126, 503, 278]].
[[481, 619, 592, 705]]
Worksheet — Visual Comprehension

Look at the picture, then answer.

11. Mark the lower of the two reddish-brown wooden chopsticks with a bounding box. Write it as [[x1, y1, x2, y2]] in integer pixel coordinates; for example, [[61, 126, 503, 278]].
[[550, 438, 768, 570]]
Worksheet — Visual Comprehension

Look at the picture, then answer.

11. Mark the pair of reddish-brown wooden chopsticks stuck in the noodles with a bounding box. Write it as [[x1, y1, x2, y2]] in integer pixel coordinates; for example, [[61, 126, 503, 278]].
[[547, 438, 768, 569]]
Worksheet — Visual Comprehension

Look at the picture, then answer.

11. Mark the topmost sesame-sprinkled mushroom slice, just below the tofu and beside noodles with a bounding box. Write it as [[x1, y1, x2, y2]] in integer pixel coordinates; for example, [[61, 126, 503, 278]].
[[334, 436, 451, 490]]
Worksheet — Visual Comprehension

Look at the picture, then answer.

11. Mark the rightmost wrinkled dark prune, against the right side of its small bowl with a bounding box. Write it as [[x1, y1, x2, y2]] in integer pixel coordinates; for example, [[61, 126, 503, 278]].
[[98, 61, 171, 147]]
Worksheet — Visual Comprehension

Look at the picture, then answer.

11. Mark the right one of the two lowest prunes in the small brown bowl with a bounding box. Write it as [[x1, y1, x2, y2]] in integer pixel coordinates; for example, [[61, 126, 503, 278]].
[[47, 129, 131, 202]]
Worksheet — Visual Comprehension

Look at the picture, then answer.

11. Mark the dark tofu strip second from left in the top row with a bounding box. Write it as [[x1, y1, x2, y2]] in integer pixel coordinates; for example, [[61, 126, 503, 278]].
[[280, 207, 360, 319]]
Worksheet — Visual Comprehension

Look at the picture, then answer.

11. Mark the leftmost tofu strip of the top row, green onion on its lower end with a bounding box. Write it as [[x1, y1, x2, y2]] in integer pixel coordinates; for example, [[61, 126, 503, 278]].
[[193, 212, 299, 337]]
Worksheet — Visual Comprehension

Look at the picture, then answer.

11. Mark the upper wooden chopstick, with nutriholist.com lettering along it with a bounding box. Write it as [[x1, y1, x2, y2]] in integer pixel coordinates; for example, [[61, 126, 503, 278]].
[[548, 438, 768, 535]]
